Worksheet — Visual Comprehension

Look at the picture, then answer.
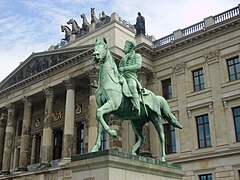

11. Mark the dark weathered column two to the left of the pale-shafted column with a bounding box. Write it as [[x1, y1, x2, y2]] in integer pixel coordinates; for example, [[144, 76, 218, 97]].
[[18, 97, 32, 171]]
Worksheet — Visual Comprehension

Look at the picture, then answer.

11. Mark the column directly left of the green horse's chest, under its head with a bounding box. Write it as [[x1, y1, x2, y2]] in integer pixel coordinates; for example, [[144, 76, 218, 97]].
[[87, 68, 98, 151]]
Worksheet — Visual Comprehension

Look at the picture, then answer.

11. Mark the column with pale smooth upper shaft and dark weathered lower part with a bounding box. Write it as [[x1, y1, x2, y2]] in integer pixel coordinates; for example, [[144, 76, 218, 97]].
[[63, 79, 75, 160]]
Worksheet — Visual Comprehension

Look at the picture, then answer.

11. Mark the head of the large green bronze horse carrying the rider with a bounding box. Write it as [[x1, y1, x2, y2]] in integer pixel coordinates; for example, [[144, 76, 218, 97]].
[[92, 38, 108, 63]]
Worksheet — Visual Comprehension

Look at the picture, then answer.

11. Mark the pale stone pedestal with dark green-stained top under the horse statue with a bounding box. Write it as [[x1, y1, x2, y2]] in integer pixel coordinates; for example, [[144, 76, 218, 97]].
[[69, 150, 184, 180]]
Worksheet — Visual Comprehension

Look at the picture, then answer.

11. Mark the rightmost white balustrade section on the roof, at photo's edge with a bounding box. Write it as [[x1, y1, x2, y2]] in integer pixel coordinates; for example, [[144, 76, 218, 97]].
[[213, 6, 240, 24]]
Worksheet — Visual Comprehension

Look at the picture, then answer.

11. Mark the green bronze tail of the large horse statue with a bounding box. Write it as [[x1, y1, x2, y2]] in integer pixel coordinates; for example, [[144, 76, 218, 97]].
[[157, 96, 182, 129]]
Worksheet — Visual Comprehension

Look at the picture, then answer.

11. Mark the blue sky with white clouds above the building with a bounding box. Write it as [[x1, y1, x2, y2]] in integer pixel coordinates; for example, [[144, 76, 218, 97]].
[[0, 0, 239, 81]]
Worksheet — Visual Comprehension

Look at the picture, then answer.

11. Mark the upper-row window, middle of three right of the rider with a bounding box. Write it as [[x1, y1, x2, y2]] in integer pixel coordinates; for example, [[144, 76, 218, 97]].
[[192, 68, 205, 91]]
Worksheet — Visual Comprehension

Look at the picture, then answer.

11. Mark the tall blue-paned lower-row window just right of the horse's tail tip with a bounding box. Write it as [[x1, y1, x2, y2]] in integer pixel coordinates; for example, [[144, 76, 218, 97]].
[[196, 114, 211, 148]]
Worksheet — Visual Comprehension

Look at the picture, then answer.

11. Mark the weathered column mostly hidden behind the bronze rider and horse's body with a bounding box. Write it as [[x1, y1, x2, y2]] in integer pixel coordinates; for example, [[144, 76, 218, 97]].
[[138, 69, 152, 157]]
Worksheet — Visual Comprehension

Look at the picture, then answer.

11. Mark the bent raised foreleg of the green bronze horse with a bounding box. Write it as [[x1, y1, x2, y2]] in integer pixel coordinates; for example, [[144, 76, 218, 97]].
[[96, 100, 117, 137]]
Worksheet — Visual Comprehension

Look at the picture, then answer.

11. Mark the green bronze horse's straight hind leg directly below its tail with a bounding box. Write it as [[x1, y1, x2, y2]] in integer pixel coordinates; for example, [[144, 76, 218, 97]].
[[151, 115, 166, 162]]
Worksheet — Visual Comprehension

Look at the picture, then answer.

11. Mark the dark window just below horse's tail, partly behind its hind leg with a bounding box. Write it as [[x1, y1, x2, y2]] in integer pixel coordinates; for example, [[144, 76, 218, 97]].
[[163, 124, 176, 154]]
